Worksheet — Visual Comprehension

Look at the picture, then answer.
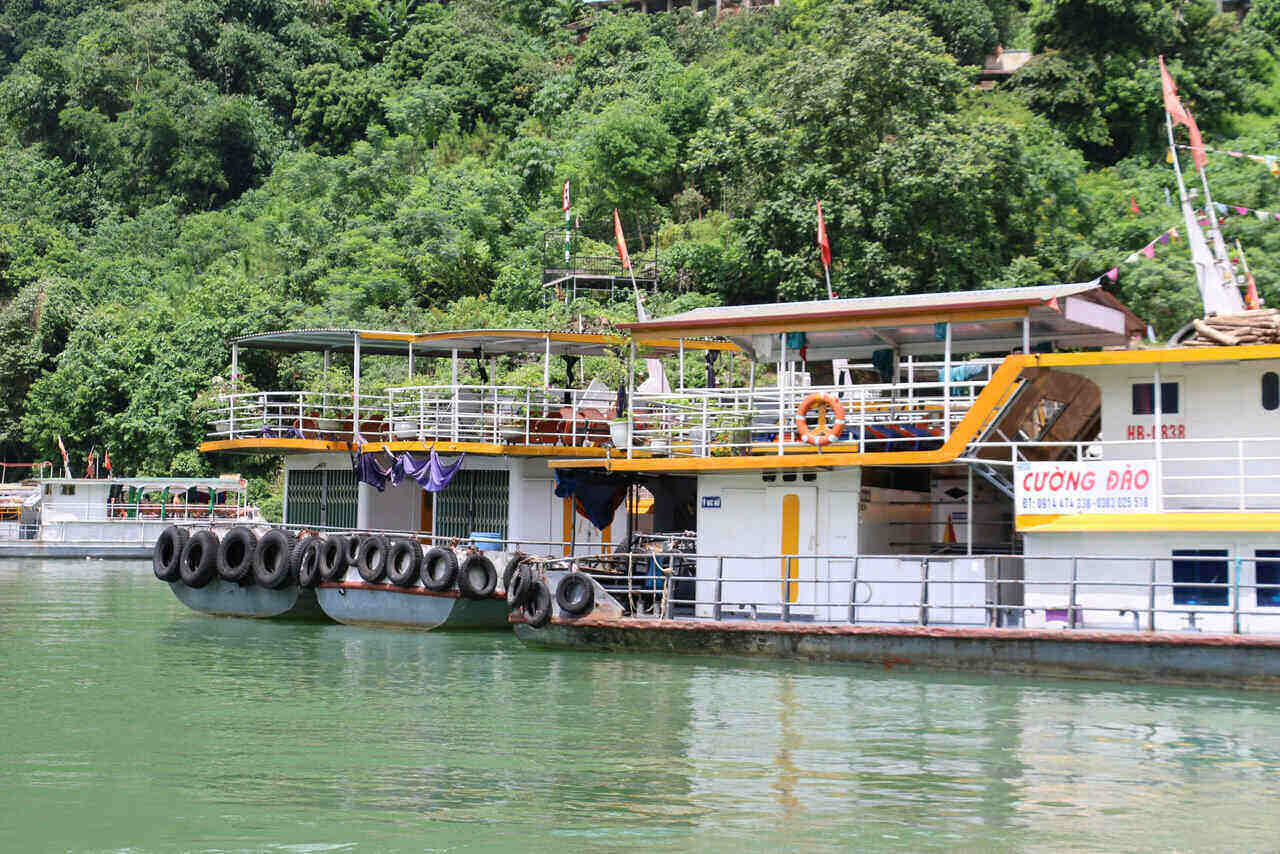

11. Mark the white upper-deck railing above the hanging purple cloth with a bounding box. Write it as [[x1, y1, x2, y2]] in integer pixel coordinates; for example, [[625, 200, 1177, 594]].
[[207, 384, 612, 446]]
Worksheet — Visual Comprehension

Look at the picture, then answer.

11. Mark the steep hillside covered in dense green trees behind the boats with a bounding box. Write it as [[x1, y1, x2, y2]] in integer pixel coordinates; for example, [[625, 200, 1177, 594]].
[[0, 0, 1280, 494]]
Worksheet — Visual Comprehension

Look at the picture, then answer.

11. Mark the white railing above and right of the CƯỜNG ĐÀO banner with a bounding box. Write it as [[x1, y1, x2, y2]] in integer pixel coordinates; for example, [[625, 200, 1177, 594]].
[[965, 437, 1280, 512]]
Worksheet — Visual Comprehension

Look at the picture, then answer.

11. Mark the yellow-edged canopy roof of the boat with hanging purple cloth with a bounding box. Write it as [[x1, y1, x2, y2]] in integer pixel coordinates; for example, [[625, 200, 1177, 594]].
[[232, 329, 737, 356]]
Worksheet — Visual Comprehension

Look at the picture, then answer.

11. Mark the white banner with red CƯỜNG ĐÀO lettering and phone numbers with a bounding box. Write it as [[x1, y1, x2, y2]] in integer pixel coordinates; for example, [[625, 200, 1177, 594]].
[[1014, 460, 1156, 516]]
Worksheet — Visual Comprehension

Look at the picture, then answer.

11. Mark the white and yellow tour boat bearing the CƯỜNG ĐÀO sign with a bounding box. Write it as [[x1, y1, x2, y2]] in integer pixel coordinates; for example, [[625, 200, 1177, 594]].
[[496, 282, 1280, 684]]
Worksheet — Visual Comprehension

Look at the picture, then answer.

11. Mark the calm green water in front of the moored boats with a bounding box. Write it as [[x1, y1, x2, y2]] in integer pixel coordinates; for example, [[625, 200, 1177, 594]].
[[0, 561, 1280, 854]]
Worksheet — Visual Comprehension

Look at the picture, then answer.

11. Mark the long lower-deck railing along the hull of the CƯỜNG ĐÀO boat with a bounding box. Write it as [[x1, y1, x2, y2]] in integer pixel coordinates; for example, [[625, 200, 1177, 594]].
[[555, 549, 1280, 634]]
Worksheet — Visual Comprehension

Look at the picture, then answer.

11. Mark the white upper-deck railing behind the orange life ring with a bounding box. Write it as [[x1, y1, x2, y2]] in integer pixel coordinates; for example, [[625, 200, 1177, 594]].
[[631, 362, 995, 457]]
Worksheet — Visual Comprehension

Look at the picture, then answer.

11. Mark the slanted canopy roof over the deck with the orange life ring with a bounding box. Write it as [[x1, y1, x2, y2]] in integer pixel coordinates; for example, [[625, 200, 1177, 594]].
[[622, 282, 1147, 361]]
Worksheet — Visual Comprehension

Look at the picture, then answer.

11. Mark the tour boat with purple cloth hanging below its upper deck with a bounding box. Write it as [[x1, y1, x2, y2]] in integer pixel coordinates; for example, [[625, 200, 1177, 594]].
[[170, 329, 735, 629]]
